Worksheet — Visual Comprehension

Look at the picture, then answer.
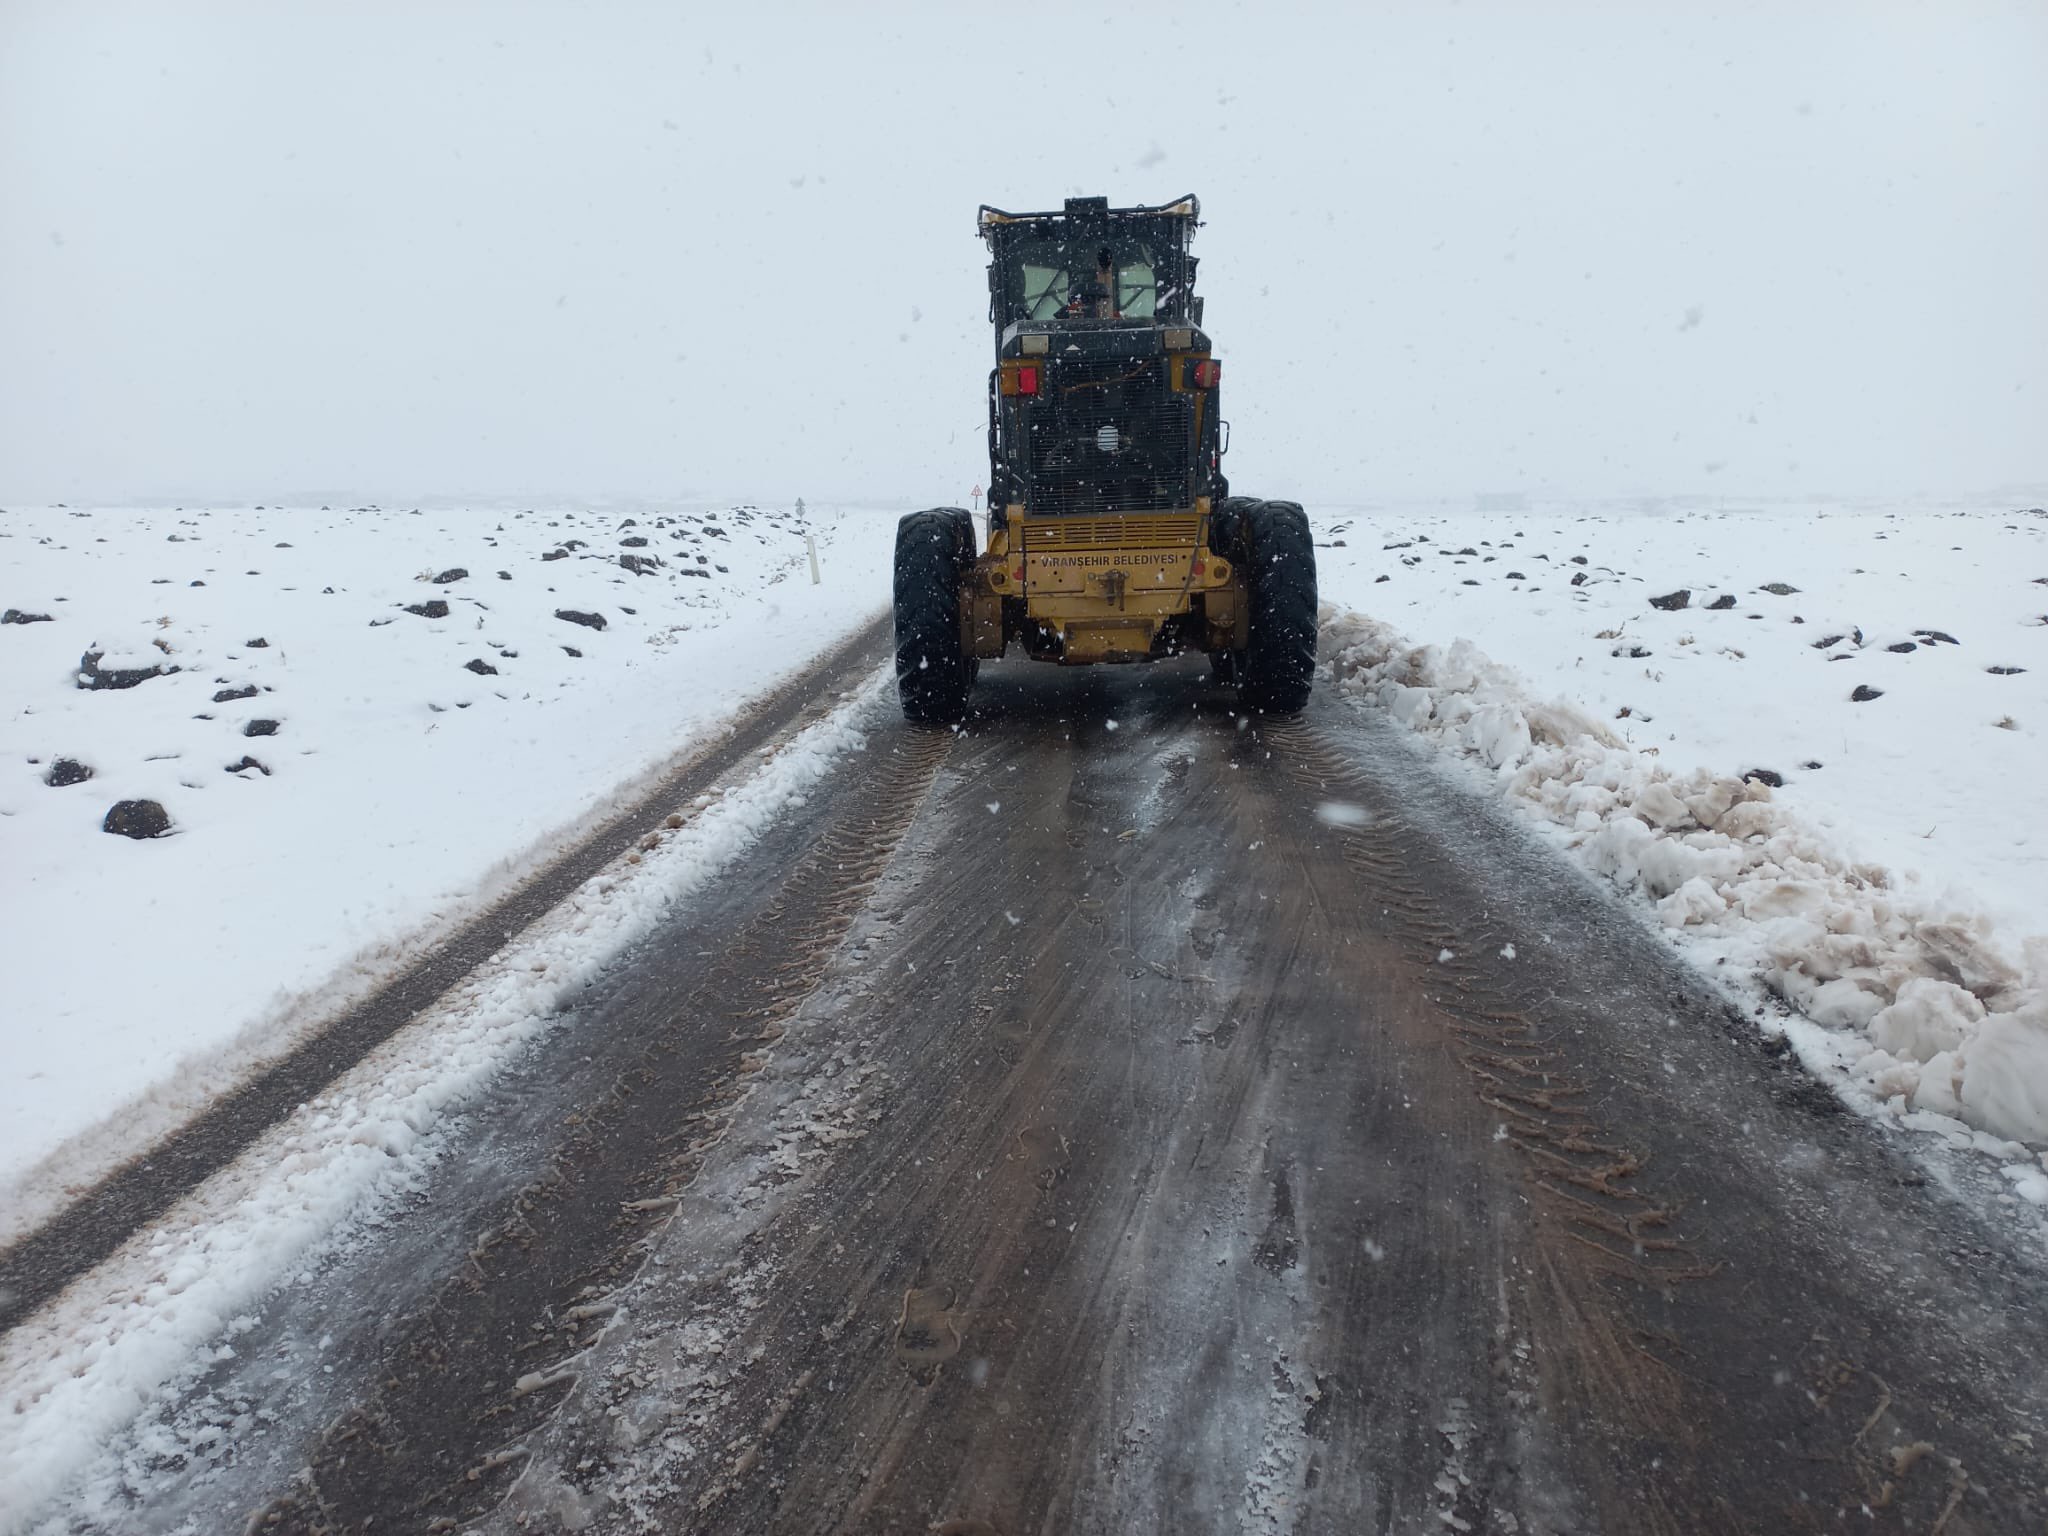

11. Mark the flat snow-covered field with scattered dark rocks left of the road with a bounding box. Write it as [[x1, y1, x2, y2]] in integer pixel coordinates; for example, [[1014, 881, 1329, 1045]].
[[0, 508, 893, 1241]]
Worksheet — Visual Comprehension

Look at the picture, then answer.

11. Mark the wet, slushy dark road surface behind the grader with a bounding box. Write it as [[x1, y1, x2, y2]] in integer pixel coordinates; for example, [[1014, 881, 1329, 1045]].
[[32, 664, 2048, 1536]]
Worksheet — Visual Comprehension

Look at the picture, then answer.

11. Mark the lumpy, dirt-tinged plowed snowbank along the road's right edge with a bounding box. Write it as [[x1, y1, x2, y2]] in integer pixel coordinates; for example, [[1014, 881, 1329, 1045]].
[[1323, 608, 2048, 1171]]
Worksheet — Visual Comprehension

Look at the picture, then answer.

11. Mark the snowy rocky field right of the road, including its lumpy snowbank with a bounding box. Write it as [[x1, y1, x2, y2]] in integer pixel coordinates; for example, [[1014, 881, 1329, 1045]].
[[1319, 504, 2048, 1163]]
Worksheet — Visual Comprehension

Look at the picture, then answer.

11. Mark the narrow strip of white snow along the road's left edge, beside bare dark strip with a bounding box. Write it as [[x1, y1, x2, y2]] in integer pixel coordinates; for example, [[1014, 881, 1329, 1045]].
[[0, 672, 889, 1536]]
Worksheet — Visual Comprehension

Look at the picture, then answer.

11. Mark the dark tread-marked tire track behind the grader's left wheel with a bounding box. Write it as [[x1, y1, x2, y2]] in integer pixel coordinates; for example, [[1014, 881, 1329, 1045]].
[[248, 729, 952, 1536]]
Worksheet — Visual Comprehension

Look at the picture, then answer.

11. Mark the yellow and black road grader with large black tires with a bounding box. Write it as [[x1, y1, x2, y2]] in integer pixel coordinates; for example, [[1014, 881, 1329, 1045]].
[[895, 197, 1315, 723]]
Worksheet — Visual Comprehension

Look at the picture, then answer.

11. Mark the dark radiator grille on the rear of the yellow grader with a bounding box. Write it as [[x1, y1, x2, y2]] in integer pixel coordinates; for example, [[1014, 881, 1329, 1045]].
[[1024, 358, 1194, 516]]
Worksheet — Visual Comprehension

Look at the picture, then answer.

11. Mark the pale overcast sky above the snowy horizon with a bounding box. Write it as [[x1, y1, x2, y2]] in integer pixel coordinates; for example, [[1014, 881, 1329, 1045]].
[[0, 0, 2048, 504]]
